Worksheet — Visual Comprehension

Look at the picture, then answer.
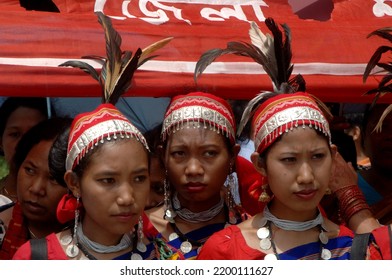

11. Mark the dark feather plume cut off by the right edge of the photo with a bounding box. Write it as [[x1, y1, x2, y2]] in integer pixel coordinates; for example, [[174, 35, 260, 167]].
[[363, 27, 392, 131]]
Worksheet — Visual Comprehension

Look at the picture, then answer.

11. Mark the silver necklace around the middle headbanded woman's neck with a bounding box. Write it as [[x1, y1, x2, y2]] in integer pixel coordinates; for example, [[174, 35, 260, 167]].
[[173, 194, 225, 223]]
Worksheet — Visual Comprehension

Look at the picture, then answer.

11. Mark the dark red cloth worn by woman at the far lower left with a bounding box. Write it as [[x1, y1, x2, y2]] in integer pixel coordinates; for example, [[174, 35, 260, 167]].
[[0, 202, 30, 260]]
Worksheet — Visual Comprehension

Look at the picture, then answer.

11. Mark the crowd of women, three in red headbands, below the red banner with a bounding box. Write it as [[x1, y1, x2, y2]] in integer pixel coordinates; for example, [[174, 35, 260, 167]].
[[0, 15, 392, 260]]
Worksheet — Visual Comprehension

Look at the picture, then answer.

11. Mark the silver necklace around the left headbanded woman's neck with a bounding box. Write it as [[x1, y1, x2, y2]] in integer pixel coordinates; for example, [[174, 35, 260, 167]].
[[76, 223, 132, 254]]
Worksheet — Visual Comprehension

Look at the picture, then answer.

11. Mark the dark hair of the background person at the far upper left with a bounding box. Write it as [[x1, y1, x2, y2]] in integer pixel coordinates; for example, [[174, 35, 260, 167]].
[[0, 97, 55, 137]]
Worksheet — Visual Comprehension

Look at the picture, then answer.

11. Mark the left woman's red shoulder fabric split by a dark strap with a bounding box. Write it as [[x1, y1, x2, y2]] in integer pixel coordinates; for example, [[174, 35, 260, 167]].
[[12, 233, 68, 260]]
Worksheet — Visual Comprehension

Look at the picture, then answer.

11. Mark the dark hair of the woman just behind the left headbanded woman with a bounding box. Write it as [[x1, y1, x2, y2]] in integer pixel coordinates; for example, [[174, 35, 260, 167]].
[[11, 117, 72, 183]]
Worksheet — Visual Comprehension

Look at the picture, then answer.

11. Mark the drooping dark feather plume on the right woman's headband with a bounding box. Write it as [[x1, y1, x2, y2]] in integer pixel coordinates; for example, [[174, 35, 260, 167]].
[[194, 18, 331, 135]]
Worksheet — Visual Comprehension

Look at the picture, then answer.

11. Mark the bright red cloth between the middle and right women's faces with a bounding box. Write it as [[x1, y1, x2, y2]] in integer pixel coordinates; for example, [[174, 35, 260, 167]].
[[236, 156, 264, 216]]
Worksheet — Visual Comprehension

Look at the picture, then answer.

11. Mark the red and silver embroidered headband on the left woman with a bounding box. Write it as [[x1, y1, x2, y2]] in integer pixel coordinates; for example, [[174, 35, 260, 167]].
[[66, 103, 149, 170]]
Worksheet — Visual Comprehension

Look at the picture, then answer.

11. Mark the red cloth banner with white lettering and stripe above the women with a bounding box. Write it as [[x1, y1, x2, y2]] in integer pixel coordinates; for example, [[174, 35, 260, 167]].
[[0, 0, 392, 103]]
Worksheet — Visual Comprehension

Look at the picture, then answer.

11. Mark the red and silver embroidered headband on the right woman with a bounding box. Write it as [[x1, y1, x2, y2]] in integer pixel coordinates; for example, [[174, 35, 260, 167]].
[[252, 92, 331, 154]]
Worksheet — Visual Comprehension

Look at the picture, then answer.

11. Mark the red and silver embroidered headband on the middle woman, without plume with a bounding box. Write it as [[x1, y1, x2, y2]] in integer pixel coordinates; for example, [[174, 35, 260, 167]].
[[161, 92, 235, 144]]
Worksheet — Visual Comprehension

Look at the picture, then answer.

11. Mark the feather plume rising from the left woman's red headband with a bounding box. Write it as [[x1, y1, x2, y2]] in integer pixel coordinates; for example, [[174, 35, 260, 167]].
[[59, 12, 173, 105]]
